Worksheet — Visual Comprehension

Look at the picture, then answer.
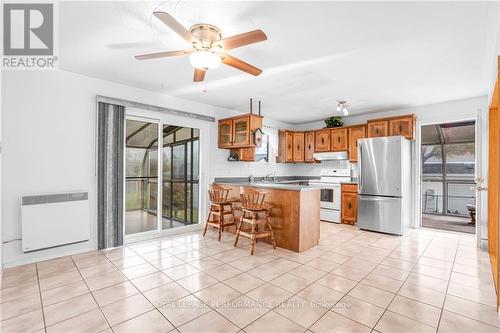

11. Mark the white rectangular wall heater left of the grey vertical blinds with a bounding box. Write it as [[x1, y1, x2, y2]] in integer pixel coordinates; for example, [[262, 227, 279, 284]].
[[21, 192, 90, 252]]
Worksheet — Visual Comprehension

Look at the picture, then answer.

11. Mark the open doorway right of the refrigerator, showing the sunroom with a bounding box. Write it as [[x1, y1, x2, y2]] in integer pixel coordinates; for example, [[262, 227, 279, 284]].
[[420, 121, 476, 234]]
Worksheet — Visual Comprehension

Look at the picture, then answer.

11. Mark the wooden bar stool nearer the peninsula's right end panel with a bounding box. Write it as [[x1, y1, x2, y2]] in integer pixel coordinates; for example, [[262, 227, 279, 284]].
[[234, 187, 276, 255]]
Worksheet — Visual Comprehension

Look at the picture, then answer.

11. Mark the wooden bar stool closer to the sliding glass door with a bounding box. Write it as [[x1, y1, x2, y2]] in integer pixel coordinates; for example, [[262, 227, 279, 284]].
[[203, 184, 236, 242]]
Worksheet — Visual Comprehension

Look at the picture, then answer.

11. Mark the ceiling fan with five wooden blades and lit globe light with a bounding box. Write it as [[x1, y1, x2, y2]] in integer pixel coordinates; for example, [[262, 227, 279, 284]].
[[135, 12, 267, 82]]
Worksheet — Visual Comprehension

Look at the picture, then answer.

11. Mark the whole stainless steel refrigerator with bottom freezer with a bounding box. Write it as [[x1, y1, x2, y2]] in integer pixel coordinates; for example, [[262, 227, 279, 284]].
[[357, 136, 412, 235]]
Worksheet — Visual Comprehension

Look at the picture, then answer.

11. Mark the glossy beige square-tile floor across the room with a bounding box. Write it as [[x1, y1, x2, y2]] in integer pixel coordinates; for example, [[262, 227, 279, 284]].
[[0, 223, 500, 333]]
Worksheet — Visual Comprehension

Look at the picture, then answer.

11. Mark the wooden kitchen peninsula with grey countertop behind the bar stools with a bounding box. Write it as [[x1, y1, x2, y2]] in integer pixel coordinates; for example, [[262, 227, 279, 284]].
[[215, 179, 320, 252]]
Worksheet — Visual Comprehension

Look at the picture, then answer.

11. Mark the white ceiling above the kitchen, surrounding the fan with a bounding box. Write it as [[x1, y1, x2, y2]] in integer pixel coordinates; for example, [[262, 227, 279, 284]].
[[60, 1, 499, 123]]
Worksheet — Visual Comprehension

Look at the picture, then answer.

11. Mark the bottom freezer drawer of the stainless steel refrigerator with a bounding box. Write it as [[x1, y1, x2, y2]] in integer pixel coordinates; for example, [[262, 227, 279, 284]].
[[358, 195, 404, 235]]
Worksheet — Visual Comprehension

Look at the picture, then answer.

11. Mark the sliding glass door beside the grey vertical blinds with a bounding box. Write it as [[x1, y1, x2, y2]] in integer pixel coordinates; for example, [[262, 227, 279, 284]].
[[124, 118, 199, 235]]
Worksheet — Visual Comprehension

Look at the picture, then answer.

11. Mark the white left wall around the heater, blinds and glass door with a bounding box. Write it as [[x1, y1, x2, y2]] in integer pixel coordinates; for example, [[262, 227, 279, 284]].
[[1, 71, 296, 266]]
